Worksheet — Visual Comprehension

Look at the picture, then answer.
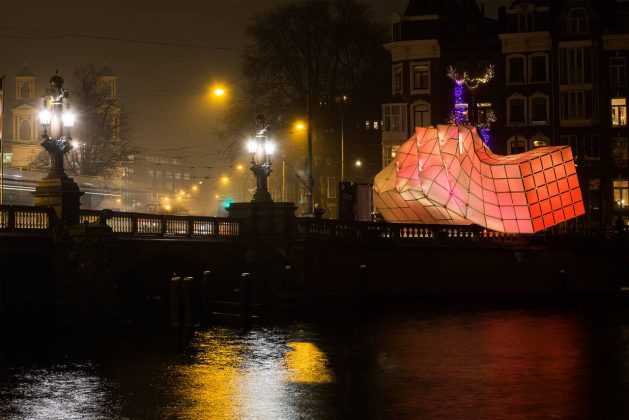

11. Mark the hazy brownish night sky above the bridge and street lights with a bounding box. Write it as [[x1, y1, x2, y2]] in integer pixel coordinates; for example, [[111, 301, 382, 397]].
[[0, 0, 495, 171]]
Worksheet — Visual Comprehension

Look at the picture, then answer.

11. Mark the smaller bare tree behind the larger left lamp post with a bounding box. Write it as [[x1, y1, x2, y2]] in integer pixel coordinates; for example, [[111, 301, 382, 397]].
[[68, 64, 137, 176]]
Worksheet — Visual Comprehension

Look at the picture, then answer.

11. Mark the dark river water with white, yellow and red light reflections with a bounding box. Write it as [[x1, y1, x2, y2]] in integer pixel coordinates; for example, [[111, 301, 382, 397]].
[[0, 302, 629, 419]]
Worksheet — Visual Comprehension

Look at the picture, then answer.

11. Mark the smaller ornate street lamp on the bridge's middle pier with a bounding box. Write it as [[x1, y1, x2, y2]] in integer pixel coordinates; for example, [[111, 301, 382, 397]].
[[247, 114, 275, 202]]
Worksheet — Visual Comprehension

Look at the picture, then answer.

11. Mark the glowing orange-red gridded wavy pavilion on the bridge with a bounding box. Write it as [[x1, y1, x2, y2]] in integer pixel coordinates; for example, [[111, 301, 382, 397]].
[[374, 125, 585, 233]]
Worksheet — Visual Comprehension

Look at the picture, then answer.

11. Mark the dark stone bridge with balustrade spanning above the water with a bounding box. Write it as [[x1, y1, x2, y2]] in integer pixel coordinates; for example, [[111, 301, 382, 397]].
[[0, 203, 629, 326]]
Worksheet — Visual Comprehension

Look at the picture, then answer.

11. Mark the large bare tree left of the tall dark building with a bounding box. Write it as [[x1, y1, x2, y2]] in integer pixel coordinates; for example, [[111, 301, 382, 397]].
[[221, 0, 388, 158]]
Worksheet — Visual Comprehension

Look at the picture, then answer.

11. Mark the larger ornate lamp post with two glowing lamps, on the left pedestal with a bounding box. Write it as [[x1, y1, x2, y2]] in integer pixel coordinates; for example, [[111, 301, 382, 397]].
[[33, 72, 83, 224]]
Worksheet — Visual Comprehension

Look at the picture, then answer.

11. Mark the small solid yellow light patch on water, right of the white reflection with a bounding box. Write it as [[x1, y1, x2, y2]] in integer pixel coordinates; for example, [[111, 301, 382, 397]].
[[284, 342, 333, 384]]
